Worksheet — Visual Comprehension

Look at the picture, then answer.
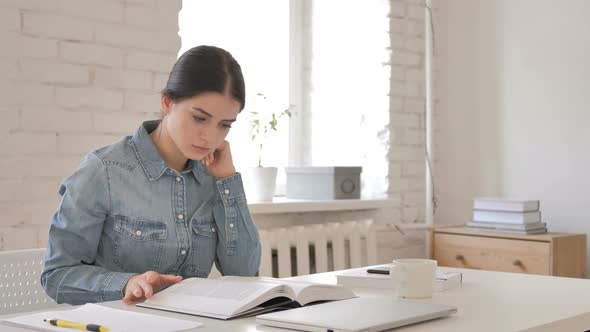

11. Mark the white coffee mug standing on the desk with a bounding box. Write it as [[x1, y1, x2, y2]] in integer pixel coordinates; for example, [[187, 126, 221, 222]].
[[389, 259, 437, 299]]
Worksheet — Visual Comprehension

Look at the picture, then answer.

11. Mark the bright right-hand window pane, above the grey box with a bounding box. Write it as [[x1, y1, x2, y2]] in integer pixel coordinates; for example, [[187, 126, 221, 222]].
[[309, 0, 390, 196]]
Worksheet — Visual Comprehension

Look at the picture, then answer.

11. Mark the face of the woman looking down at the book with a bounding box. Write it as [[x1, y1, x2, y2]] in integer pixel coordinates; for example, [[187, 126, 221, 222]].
[[162, 92, 241, 160]]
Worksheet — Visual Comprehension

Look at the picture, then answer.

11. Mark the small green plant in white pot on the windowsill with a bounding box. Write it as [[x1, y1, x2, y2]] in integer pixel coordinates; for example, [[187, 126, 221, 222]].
[[246, 92, 292, 201]]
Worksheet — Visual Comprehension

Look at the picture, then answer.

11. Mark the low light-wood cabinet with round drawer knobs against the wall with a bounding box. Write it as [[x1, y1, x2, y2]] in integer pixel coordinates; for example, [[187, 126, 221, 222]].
[[432, 227, 586, 278]]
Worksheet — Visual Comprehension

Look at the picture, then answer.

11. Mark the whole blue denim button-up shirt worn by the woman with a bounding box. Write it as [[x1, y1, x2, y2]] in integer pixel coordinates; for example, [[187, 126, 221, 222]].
[[41, 121, 260, 304]]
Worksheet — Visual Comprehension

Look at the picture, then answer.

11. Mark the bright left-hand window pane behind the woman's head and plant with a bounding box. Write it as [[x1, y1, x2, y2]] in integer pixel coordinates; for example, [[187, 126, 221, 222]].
[[179, 0, 289, 169]]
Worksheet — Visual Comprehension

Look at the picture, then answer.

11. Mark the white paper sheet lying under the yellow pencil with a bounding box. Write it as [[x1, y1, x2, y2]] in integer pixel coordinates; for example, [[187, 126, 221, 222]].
[[0, 304, 203, 332]]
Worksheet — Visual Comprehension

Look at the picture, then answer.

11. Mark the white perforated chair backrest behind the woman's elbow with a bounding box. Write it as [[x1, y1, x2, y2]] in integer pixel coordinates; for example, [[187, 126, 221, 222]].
[[0, 249, 63, 314]]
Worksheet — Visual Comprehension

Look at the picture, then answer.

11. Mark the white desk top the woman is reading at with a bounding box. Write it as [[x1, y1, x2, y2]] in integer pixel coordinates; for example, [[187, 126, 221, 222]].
[[1, 268, 590, 332]]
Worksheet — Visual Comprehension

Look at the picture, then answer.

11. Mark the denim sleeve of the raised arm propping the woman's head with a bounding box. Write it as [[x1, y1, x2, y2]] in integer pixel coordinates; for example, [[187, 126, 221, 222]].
[[213, 173, 260, 276]]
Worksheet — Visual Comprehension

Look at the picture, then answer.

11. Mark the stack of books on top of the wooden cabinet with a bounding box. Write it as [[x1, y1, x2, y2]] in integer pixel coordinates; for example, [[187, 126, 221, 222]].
[[466, 198, 547, 234]]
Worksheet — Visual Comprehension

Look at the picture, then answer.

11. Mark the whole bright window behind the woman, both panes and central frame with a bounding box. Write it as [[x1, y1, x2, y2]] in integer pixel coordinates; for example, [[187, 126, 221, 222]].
[[180, 0, 390, 196]]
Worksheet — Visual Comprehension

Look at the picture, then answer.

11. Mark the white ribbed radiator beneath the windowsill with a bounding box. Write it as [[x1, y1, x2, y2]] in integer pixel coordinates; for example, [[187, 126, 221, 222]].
[[258, 220, 377, 278]]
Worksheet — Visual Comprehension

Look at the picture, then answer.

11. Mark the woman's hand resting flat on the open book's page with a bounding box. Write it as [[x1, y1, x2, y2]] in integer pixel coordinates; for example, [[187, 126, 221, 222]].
[[123, 271, 182, 303]]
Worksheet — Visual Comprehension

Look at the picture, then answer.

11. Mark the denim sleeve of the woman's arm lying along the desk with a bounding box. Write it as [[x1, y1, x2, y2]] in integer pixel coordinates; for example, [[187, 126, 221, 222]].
[[41, 153, 133, 304]]
